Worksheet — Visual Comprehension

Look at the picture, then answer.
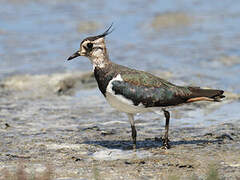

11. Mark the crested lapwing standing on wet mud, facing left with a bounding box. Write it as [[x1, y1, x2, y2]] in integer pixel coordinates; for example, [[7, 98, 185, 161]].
[[67, 24, 225, 149]]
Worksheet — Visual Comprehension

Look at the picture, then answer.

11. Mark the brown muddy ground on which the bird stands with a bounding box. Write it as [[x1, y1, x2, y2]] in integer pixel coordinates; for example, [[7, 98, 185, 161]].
[[0, 73, 240, 180]]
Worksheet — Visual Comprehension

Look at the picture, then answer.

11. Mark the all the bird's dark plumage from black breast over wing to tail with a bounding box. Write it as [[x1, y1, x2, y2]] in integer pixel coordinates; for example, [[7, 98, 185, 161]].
[[94, 62, 223, 107]]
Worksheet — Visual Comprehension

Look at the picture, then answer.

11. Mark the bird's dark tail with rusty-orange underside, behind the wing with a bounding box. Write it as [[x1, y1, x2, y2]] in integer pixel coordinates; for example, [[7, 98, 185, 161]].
[[187, 87, 225, 102]]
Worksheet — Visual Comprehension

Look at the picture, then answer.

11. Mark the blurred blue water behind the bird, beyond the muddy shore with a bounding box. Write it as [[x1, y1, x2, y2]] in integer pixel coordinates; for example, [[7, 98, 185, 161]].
[[0, 0, 240, 93]]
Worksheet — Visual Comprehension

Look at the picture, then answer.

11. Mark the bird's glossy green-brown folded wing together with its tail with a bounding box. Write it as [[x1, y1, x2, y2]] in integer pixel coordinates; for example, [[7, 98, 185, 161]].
[[112, 71, 224, 107]]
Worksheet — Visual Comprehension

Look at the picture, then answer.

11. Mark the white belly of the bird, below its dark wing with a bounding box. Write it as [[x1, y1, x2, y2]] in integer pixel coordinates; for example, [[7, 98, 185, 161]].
[[106, 92, 151, 114]]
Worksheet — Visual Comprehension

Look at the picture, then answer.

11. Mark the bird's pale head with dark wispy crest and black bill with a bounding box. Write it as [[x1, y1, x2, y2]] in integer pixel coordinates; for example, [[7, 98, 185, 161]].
[[67, 24, 113, 63]]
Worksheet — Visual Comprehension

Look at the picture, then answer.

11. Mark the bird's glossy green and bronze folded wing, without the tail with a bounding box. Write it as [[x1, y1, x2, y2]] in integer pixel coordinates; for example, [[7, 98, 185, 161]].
[[111, 69, 191, 107]]
